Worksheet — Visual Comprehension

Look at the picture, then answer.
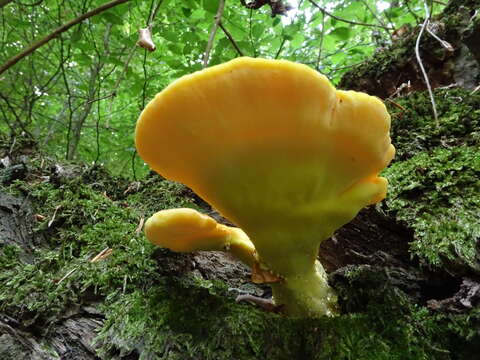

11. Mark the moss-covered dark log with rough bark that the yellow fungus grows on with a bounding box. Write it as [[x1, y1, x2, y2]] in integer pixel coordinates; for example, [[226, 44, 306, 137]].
[[0, 0, 480, 360]]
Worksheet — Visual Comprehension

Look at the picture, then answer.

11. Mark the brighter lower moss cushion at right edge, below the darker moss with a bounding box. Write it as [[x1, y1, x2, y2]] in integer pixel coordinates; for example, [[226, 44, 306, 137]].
[[384, 146, 480, 271]]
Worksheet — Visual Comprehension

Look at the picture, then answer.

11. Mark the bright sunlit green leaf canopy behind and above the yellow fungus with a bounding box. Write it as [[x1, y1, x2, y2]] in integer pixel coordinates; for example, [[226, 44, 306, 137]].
[[0, 0, 445, 177]]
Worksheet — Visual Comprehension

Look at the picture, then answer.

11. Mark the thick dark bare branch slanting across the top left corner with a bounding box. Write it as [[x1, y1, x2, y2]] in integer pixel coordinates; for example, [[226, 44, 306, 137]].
[[0, 0, 130, 75]]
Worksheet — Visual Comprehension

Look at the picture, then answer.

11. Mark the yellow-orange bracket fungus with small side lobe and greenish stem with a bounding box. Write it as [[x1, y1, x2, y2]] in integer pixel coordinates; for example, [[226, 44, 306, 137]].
[[135, 57, 395, 317]]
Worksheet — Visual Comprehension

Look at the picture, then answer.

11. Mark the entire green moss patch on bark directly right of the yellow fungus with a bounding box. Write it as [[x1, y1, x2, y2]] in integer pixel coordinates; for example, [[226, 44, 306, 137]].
[[383, 89, 480, 273]]
